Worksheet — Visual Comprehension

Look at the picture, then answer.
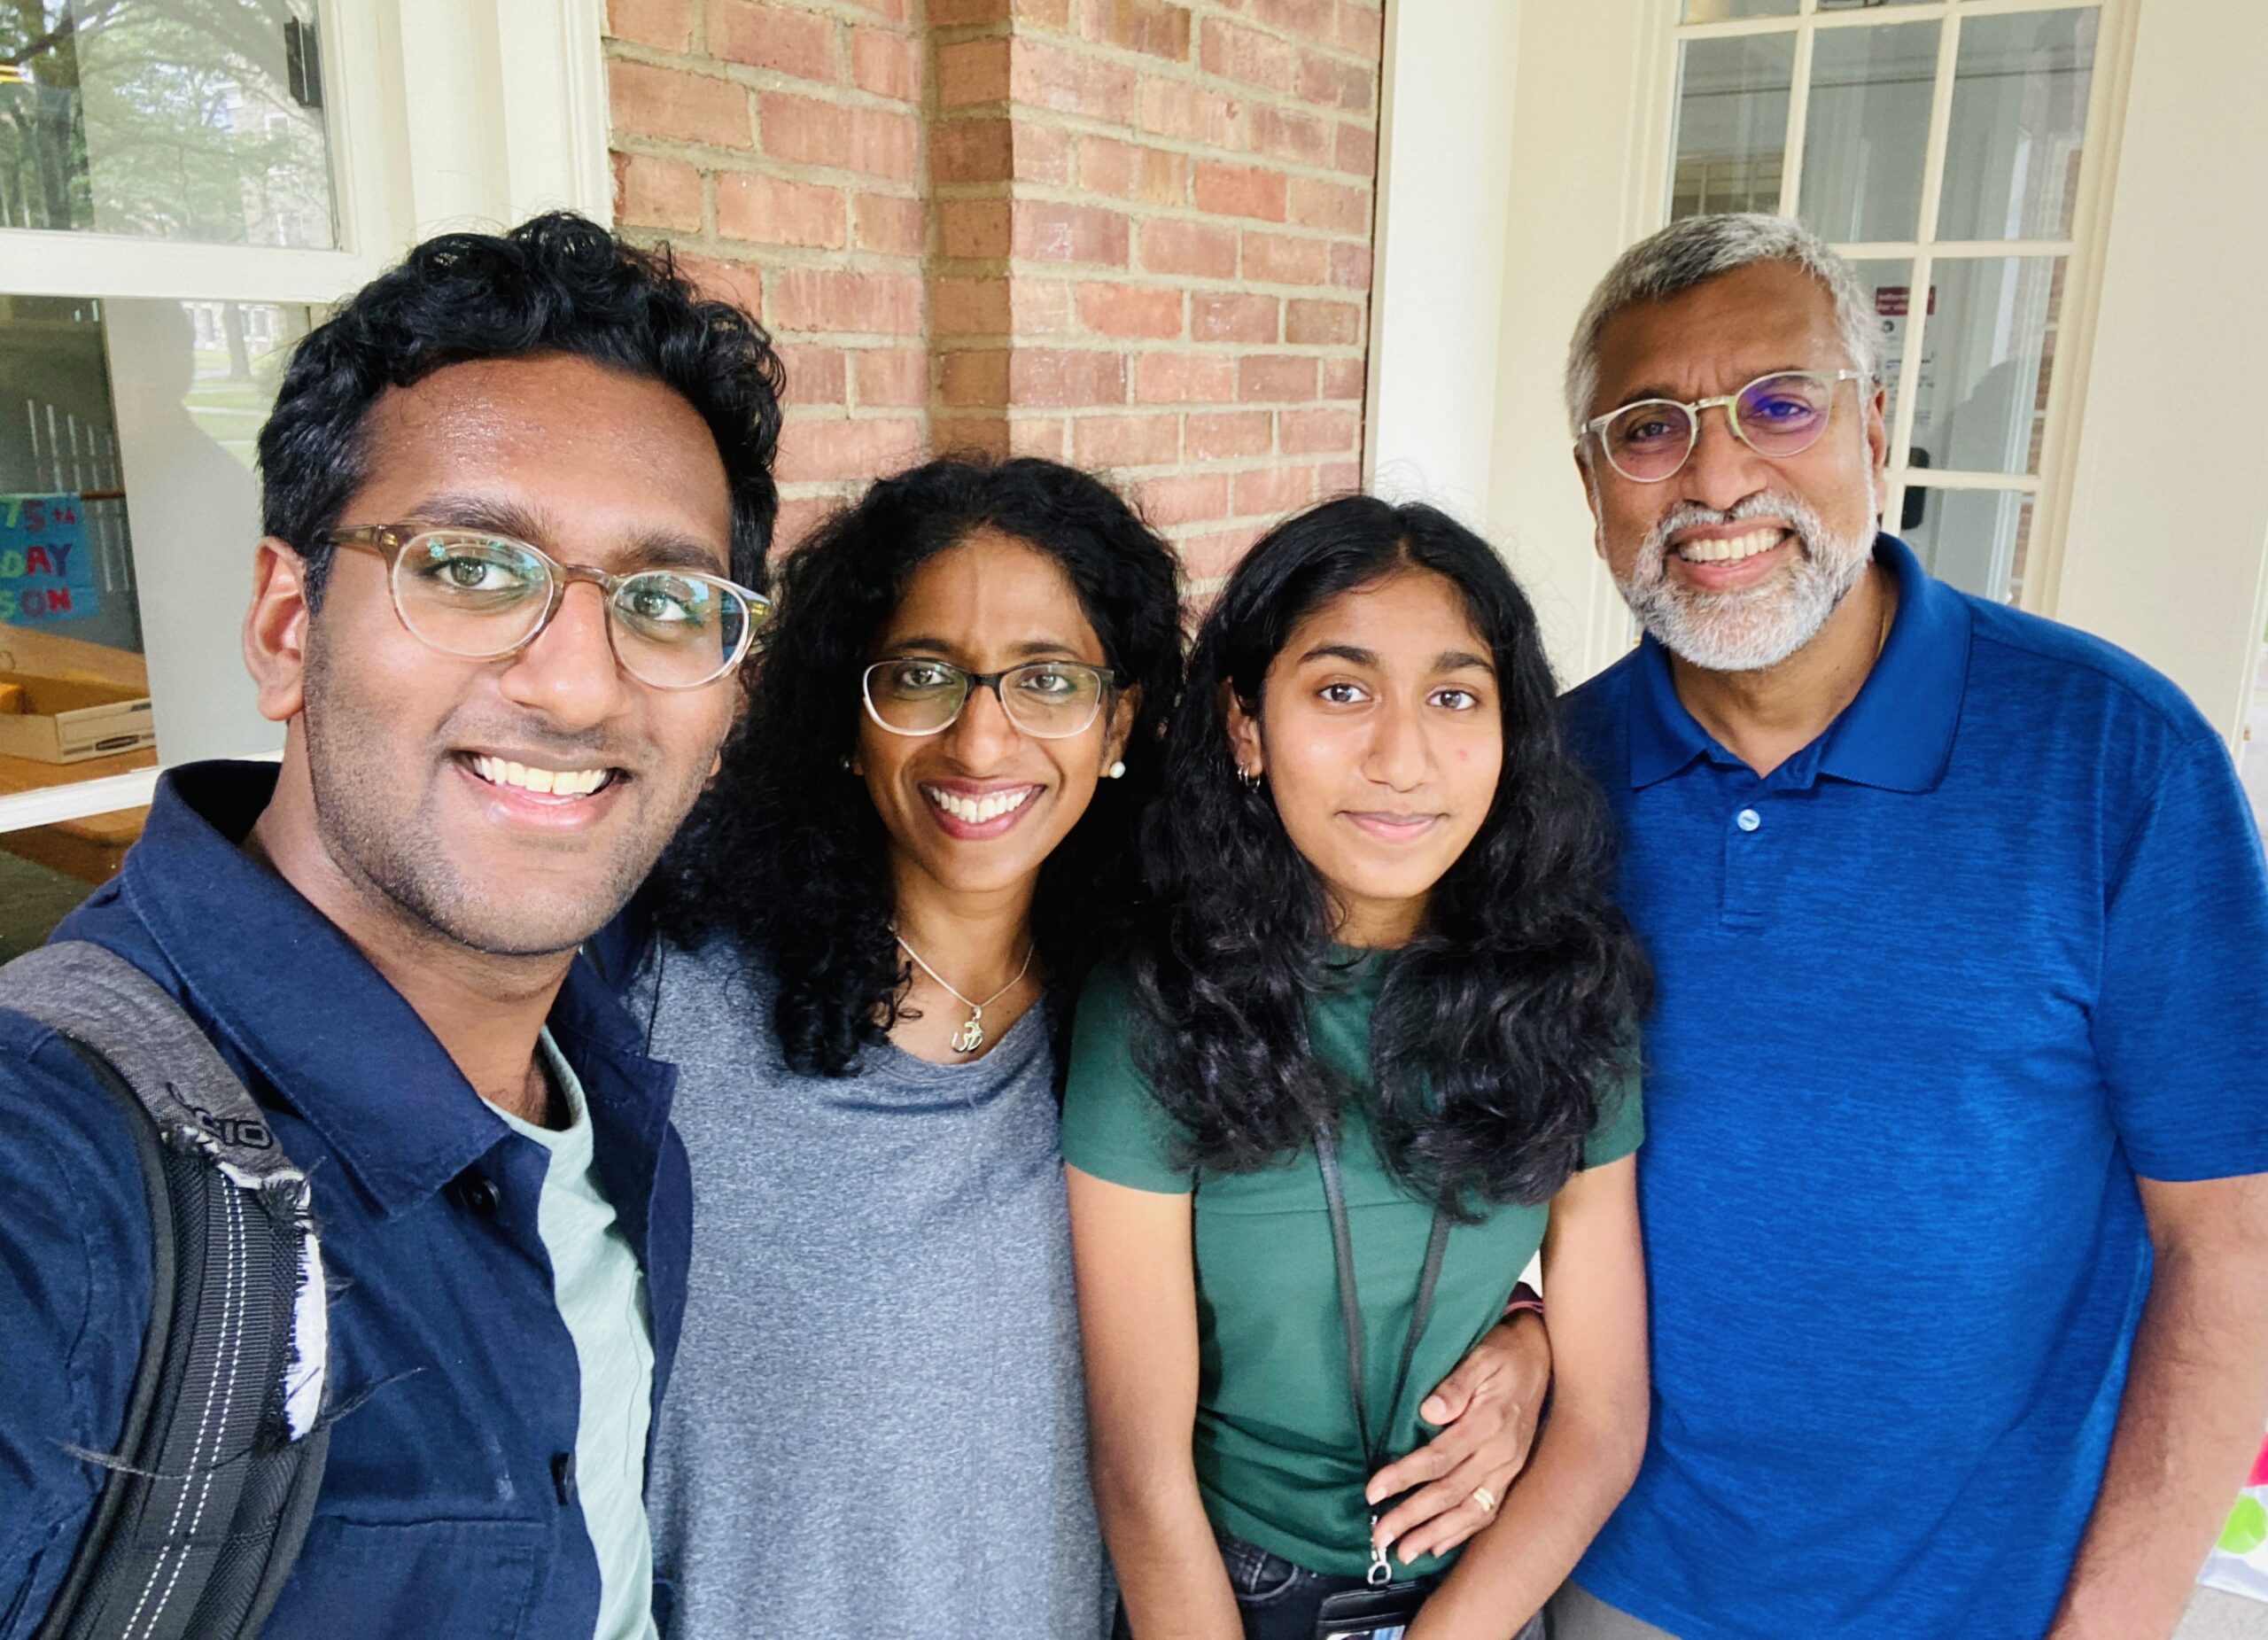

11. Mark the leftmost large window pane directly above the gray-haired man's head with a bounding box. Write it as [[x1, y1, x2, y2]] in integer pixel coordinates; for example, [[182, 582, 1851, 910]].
[[1669, 34, 1797, 220]]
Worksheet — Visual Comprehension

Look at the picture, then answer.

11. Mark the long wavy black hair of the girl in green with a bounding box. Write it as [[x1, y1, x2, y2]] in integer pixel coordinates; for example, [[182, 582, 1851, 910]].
[[1130, 497, 1653, 1218]]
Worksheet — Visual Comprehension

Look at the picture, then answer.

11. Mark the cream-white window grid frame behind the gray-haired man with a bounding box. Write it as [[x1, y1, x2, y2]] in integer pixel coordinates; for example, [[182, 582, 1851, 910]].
[[1651, 0, 2134, 617]]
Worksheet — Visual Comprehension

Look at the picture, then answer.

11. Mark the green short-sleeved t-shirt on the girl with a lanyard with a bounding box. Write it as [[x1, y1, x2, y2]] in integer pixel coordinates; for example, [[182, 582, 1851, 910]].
[[1064, 952, 1644, 1576]]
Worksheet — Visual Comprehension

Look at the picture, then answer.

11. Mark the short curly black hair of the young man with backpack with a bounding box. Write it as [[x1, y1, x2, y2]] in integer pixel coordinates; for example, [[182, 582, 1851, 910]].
[[260, 211, 787, 606]]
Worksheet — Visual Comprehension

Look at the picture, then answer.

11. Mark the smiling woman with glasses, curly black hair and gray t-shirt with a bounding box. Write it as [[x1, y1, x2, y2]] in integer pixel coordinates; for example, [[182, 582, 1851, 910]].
[[602, 461, 1549, 1640]]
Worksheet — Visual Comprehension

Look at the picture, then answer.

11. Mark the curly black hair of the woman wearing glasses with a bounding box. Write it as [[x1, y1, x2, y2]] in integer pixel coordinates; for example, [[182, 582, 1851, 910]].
[[651, 456, 1182, 1076]]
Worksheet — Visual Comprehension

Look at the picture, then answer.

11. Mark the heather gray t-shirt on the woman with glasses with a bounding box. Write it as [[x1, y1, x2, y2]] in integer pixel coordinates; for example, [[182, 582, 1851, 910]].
[[631, 941, 1111, 1640]]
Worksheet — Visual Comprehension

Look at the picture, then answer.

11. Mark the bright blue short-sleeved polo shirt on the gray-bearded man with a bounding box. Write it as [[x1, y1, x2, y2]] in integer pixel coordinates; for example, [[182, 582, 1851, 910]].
[[1567, 535, 2268, 1640]]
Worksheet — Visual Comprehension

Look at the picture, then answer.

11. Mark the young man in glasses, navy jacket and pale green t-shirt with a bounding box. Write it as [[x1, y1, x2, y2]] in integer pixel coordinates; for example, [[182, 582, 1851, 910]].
[[0, 215, 781, 1640]]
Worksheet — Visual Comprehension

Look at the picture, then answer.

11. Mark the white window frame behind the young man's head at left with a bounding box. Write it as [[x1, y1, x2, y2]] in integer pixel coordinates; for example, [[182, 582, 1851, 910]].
[[0, 0, 612, 833]]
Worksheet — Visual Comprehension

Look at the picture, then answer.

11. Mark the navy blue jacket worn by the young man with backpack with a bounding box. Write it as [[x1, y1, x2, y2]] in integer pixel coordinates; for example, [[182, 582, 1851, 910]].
[[0, 765, 692, 1640]]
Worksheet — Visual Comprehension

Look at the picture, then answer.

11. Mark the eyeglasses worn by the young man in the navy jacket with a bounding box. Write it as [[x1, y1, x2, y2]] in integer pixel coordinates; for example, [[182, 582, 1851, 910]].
[[322, 524, 771, 689]]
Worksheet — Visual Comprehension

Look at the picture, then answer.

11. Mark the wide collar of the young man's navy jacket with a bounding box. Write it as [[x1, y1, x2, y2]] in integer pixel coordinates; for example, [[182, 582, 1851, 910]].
[[118, 762, 667, 1216]]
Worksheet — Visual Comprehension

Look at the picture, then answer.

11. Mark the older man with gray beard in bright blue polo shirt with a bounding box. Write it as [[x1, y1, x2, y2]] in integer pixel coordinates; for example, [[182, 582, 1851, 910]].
[[1554, 215, 2268, 1640]]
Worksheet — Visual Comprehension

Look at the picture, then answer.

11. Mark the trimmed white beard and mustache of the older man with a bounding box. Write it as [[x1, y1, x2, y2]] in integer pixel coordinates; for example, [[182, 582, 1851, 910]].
[[1615, 493, 1874, 672]]
